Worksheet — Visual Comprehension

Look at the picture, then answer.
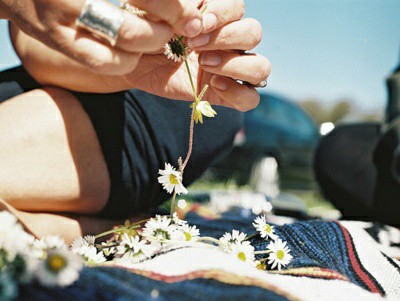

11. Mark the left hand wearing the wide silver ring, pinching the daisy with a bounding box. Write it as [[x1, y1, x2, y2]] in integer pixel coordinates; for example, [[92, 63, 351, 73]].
[[0, 0, 202, 75]]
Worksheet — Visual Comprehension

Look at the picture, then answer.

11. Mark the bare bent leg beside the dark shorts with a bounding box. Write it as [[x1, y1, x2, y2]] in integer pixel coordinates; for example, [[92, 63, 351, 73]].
[[0, 88, 111, 241]]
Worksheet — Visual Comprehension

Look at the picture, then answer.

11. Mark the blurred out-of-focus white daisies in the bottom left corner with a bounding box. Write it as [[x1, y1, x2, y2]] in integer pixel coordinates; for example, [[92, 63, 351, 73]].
[[0, 211, 83, 300]]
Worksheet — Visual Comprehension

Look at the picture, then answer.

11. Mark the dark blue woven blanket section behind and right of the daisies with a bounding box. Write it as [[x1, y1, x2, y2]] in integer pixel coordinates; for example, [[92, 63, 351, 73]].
[[186, 212, 382, 288]]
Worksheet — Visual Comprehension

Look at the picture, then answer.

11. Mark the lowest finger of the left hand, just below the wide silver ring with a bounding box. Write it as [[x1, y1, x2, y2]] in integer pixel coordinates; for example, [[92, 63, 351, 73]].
[[53, 27, 141, 75]]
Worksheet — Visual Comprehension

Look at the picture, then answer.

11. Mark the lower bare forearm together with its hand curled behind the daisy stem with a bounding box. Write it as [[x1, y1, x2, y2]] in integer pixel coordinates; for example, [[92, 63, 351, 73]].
[[11, 0, 271, 111]]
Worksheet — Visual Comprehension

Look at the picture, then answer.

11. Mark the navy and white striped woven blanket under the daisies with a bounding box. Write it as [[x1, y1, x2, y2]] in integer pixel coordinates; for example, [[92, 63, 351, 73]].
[[20, 207, 400, 301]]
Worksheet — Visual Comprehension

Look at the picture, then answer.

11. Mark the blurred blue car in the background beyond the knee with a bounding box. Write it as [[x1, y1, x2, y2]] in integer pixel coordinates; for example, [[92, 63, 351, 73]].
[[211, 93, 319, 190]]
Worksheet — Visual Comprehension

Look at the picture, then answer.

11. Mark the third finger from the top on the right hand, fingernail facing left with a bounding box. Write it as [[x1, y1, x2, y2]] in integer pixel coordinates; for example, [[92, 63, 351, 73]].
[[199, 51, 271, 85]]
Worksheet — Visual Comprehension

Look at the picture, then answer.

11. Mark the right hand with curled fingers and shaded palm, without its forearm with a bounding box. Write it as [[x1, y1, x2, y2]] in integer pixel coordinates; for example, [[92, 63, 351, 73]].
[[124, 0, 270, 111]]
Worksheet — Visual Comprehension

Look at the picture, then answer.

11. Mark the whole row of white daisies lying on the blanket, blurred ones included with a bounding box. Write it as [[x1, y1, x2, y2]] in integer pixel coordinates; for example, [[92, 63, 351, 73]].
[[0, 211, 292, 300]]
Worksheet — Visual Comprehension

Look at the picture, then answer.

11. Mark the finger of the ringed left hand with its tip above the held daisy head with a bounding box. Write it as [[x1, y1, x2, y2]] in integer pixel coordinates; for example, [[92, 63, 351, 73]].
[[129, 0, 203, 37]]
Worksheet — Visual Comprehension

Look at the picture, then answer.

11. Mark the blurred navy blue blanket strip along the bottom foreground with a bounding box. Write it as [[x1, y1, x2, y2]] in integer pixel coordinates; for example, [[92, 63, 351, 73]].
[[19, 268, 287, 301]]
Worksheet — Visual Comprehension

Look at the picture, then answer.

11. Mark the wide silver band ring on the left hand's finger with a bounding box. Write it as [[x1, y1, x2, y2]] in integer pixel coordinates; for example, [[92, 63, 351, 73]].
[[76, 0, 124, 47]]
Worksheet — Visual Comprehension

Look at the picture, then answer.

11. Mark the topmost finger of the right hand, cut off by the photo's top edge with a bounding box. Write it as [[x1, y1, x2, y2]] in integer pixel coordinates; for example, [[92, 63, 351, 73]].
[[202, 0, 245, 33]]
